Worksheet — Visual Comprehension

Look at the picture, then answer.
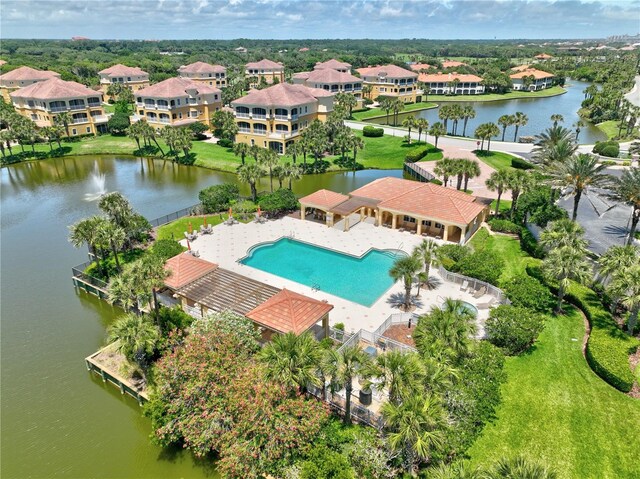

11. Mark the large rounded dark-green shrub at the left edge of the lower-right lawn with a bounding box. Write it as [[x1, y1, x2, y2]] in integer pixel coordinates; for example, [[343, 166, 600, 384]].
[[485, 306, 548, 356]]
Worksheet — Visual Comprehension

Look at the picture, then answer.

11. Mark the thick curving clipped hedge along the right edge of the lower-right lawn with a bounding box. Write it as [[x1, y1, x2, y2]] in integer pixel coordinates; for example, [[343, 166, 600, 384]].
[[566, 284, 640, 393]]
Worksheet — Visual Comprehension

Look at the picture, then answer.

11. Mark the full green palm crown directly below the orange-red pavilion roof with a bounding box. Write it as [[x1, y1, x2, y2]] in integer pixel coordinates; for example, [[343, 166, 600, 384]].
[[258, 332, 321, 393]]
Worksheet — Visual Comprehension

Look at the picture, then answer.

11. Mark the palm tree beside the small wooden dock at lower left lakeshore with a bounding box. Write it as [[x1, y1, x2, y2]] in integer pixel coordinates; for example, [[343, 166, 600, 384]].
[[109, 313, 160, 375]]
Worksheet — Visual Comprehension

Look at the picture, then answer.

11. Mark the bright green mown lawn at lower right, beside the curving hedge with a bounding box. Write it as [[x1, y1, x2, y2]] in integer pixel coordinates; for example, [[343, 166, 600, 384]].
[[468, 234, 640, 478]]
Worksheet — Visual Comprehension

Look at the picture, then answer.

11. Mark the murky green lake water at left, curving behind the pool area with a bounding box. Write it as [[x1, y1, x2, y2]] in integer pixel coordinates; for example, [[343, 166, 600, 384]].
[[0, 157, 402, 479]]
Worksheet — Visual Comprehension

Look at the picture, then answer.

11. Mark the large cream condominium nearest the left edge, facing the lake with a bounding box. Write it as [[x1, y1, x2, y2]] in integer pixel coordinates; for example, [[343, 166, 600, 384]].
[[10, 78, 109, 136]]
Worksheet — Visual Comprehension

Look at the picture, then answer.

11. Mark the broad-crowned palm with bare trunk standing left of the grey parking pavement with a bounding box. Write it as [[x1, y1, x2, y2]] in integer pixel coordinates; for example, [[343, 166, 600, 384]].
[[548, 153, 611, 221]]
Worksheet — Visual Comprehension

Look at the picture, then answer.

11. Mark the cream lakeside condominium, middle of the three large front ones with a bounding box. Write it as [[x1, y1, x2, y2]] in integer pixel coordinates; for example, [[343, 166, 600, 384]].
[[133, 78, 222, 128]]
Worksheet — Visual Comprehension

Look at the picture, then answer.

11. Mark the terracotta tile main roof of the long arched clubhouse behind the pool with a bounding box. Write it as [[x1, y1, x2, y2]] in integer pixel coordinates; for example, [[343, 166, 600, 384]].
[[351, 177, 486, 226]]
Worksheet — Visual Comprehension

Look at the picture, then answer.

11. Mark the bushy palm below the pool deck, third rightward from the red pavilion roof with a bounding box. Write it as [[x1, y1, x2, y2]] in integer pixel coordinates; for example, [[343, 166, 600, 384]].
[[365, 350, 425, 405]]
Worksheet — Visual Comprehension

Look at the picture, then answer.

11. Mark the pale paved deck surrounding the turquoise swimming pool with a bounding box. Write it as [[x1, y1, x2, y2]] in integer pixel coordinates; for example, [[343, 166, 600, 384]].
[[181, 217, 489, 332]]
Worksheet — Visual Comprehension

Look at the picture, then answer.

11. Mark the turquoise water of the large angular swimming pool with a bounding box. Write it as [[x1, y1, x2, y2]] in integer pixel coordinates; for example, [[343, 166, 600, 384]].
[[240, 238, 405, 306]]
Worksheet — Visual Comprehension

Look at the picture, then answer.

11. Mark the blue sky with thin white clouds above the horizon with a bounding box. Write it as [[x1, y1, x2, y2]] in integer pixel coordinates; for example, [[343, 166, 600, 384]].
[[0, 0, 640, 39]]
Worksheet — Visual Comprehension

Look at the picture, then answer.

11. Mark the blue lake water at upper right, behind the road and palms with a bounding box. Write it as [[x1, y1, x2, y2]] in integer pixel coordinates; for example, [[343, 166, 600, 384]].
[[364, 80, 606, 144]]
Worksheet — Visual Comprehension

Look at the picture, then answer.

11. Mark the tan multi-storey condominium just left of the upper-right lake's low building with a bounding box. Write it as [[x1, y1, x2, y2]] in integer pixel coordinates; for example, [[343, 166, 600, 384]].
[[358, 65, 418, 103]]
